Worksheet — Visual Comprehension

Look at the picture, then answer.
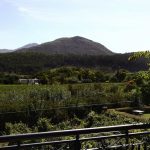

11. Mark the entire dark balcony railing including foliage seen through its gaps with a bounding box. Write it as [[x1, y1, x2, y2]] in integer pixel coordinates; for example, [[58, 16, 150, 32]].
[[0, 123, 150, 150]]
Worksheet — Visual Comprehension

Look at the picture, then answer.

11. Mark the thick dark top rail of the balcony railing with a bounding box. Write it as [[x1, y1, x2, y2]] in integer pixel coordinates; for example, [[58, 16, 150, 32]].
[[0, 123, 150, 142]]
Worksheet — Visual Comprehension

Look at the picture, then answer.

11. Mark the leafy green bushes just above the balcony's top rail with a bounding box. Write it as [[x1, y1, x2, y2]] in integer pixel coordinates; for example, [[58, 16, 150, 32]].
[[3, 109, 144, 134]]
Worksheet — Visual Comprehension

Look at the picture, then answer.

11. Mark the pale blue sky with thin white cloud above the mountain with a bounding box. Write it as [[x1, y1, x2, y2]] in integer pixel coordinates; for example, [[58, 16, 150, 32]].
[[0, 0, 150, 53]]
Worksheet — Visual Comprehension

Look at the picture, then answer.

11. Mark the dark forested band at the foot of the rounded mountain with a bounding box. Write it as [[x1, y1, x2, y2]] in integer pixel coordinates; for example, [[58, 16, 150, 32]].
[[0, 53, 148, 74]]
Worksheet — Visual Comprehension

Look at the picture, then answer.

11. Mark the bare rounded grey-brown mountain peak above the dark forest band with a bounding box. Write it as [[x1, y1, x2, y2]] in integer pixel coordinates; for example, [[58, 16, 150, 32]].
[[15, 36, 114, 55]]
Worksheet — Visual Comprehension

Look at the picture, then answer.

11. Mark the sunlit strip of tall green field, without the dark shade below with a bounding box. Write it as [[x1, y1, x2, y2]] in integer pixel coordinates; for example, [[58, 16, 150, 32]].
[[0, 83, 129, 112]]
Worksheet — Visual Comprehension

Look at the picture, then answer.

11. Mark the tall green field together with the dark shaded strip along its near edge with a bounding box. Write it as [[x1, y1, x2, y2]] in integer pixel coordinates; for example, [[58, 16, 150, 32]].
[[0, 83, 129, 132]]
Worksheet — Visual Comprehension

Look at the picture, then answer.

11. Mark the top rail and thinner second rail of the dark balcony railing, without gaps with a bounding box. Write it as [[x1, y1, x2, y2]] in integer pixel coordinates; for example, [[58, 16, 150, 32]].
[[0, 123, 150, 150]]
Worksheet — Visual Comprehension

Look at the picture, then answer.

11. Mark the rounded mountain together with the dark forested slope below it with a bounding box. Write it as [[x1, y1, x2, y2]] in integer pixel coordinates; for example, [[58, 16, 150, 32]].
[[0, 36, 148, 74]]
